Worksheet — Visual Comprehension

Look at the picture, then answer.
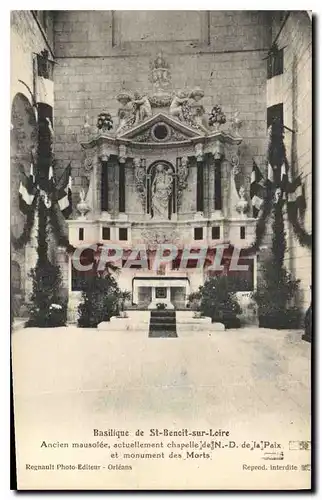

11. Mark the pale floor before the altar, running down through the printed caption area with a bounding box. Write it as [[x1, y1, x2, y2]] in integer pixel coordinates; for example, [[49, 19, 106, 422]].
[[12, 326, 311, 489]]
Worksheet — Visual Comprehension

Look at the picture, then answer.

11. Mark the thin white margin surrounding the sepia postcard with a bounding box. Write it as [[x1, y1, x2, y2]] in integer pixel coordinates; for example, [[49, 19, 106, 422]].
[[0, 4, 322, 498]]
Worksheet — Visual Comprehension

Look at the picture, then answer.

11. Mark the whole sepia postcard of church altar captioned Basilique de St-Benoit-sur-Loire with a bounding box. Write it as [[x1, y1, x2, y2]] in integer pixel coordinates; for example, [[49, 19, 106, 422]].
[[10, 10, 312, 490]]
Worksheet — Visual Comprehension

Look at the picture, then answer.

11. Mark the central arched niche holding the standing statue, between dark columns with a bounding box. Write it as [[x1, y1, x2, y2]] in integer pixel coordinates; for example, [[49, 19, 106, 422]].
[[147, 160, 176, 219]]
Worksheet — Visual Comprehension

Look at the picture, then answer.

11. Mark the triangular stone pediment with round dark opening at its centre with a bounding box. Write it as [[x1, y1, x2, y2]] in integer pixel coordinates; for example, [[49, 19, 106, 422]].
[[118, 113, 204, 144]]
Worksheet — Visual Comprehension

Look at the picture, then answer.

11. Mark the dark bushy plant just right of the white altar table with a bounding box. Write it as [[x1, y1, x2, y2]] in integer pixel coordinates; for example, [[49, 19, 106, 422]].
[[199, 275, 242, 328]]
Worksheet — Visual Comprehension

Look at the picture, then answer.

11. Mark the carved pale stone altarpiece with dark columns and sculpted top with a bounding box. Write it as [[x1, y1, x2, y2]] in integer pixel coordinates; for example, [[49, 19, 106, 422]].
[[67, 54, 256, 310]]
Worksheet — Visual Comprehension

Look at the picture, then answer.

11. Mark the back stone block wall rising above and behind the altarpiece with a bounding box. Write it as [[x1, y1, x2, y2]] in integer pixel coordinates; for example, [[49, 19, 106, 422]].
[[54, 11, 270, 209]]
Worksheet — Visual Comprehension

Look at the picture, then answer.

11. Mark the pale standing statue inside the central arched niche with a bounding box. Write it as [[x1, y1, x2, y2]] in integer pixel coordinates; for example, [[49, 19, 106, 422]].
[[151, 164, 173, 220]]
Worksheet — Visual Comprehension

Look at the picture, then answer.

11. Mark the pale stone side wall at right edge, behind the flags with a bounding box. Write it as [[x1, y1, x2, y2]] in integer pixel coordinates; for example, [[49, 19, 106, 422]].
[[272, 11, 312, 309]]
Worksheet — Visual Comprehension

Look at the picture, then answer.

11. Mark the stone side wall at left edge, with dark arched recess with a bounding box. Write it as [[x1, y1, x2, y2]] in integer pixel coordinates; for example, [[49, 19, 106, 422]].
[[10, 10, 52, 306]]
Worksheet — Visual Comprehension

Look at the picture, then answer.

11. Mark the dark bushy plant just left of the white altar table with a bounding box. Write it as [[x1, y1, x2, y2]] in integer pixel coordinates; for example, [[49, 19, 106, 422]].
[[78, 273, 120, 328]]
